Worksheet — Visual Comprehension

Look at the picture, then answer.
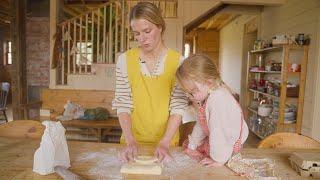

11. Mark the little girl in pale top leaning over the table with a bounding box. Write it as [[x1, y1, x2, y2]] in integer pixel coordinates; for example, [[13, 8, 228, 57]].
[[176, 55, 249, 166]]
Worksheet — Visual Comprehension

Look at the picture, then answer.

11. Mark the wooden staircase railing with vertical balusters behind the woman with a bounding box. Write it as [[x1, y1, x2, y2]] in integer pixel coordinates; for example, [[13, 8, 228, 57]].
[[56, 0, 177, 85]]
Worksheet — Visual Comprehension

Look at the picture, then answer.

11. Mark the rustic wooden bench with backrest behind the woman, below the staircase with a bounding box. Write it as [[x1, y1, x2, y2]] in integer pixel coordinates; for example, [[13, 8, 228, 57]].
[[40, 89, 121, 142]]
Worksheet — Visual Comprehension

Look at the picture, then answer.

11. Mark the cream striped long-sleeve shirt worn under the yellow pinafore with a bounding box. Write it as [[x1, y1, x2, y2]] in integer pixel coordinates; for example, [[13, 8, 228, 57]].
[[112, 50, 188, 116]]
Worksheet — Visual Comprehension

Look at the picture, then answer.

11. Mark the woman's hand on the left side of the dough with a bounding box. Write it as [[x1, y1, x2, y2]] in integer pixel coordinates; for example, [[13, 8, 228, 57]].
[[119, 140, 138, 163]]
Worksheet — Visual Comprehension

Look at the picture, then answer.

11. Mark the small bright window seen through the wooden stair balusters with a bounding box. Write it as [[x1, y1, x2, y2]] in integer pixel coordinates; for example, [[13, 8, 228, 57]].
[[76, 42, 93, 65]]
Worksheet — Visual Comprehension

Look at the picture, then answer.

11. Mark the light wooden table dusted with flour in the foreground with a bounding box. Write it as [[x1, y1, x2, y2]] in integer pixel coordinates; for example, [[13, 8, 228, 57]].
[[0, 137, 320, 180]]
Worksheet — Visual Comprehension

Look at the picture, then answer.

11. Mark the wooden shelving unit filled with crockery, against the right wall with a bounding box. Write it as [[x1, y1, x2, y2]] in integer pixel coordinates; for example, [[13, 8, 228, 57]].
[[246, 45, 309, 139]]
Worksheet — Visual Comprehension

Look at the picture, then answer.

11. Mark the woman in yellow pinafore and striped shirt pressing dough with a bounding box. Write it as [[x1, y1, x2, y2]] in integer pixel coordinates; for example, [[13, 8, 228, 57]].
[[113, 2, 187, 162]]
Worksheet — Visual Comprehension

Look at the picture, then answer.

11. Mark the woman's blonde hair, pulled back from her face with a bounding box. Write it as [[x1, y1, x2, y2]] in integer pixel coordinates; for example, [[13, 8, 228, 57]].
[[129, 2, 166, 34]]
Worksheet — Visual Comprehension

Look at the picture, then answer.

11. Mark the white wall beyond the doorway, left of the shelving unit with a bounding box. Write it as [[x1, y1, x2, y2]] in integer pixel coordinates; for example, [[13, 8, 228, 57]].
[[219, 15, 252, 94]]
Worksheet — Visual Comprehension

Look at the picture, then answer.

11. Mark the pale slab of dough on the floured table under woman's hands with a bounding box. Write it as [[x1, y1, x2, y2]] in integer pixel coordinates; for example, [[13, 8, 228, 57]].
[[120, 156, 162, 175]]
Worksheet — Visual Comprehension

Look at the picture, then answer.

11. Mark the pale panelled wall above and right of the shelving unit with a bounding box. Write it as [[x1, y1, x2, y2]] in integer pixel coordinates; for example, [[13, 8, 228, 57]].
[[260, 0, 320, 137]]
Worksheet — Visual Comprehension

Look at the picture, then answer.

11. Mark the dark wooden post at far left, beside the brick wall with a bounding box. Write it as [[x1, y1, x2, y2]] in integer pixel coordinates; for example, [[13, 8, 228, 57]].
[[10, 0, 28, 120]]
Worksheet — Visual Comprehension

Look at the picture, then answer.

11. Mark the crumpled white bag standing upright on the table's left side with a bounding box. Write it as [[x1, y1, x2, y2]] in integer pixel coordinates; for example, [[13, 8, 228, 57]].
[[33, 121, 70, 175]]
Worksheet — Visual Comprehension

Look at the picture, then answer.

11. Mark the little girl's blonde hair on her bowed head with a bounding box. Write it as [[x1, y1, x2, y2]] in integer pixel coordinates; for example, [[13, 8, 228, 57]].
[[176, 54, 223, 90]]
